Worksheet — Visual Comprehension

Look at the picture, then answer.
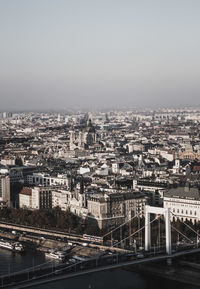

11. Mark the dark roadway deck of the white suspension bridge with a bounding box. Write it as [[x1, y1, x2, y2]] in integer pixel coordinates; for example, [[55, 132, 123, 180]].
[[3, 248, 200, 289]]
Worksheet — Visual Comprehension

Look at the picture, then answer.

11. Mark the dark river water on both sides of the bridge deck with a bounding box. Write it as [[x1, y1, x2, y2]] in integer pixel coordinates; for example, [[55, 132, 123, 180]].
[[0, 249, 200, 289]]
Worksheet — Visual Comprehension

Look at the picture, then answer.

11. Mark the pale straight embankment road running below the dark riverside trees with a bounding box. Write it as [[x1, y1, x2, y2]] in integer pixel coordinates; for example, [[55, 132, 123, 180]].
[[0, 221, 127, 253]]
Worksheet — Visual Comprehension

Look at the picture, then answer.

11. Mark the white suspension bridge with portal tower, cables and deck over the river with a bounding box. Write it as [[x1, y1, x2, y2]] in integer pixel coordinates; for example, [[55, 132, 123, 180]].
[[0, 206, 200, 289]]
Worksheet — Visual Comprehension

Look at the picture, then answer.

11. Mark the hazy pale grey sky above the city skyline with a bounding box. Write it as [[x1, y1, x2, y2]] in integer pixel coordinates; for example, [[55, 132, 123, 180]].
[[0, 0, 200, 110]]
